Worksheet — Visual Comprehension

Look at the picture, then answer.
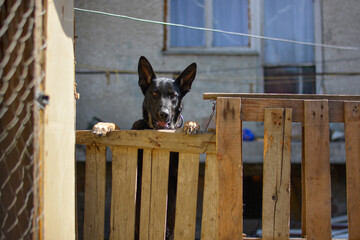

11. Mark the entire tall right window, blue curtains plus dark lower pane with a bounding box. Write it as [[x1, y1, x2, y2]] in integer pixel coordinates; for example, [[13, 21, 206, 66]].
[[264, 0, 315, 93]]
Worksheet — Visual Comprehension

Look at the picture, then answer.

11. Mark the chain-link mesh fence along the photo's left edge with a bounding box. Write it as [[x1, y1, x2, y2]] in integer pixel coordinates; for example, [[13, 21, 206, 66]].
[[0, 0, 44, 237]]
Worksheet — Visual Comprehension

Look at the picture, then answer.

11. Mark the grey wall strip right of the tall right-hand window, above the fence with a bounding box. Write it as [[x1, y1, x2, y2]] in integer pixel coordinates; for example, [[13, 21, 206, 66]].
[[322, 0, 360, 95]]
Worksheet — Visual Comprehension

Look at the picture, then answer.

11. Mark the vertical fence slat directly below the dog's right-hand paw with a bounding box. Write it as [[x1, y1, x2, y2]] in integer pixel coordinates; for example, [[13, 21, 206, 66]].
[[174, 153, 200, 240]]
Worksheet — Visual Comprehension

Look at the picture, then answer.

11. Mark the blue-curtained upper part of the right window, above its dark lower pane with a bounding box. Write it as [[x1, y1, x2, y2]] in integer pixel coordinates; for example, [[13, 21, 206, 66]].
[[264, 0, 314, 65]]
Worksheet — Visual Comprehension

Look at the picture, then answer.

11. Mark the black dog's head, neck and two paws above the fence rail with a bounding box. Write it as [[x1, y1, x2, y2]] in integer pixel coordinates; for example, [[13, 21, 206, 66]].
[[93, 56, 200, 136]]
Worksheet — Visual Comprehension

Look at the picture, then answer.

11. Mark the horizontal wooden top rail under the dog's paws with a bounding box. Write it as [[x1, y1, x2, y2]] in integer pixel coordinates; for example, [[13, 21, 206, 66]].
[[76, 130, 216, 153]]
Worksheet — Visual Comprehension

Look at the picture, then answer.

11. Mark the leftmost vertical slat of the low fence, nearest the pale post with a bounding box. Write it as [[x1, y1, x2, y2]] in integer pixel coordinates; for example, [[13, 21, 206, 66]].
[[84, 145, 106, 239]]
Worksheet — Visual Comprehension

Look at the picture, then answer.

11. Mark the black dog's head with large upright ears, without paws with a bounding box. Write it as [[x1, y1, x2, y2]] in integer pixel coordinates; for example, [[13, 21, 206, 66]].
[[138, 57, 196, 129]]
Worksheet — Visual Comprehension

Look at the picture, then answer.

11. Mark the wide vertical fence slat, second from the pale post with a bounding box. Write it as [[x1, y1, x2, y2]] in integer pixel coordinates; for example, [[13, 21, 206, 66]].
[[110, 146, 138, 240]]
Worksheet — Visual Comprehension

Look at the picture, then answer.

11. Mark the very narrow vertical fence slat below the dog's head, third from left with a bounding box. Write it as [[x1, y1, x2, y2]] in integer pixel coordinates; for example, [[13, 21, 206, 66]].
[[139, 148, 152, 240]]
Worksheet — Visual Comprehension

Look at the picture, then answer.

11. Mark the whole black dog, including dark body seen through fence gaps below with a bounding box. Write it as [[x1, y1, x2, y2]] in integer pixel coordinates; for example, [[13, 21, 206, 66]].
[[93, 57, 200, 239]]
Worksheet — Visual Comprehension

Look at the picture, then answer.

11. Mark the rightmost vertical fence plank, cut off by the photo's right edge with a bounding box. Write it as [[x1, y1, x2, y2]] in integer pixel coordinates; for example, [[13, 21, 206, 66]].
[[344, 102, 360, 240]]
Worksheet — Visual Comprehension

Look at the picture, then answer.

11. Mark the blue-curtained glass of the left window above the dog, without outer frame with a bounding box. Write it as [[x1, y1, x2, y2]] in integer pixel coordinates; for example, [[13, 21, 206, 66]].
[[169, 0, 250, 48]]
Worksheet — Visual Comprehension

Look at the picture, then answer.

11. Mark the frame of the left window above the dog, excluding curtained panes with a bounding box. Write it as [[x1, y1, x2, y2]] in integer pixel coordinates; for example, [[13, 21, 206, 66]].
[[163, 0, 262, 55]]
